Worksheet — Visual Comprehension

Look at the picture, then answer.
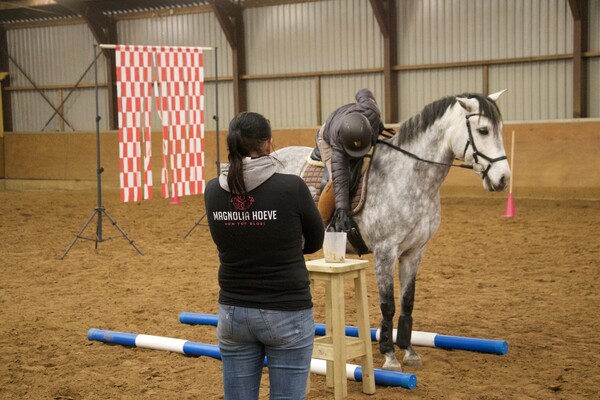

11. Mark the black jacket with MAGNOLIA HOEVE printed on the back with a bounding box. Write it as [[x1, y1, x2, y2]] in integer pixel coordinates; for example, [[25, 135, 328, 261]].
[[204, 173, 324, 310]]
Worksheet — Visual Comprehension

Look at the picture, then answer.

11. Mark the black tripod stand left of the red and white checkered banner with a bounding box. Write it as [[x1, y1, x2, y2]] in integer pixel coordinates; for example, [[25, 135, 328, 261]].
[[60, 45, 143, 260]]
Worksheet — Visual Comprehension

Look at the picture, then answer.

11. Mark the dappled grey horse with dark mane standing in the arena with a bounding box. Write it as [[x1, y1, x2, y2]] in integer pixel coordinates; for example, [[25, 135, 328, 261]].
[[273, 90, 511, 371]]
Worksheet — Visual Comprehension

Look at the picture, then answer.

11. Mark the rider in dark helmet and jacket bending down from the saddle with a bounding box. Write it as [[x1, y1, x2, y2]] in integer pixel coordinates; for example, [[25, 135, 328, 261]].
[[317, 89, 383, 238]]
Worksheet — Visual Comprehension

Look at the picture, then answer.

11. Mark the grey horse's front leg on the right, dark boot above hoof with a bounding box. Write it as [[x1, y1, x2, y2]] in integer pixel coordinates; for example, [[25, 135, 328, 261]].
[[396, 249, 423, 367]]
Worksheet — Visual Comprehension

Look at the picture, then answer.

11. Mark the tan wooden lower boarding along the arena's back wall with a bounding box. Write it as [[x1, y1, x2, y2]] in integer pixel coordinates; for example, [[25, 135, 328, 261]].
[[4, 119, 600, 199]]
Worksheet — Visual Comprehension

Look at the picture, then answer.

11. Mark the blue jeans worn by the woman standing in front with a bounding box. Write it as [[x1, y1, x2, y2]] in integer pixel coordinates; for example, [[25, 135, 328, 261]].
[[217, 304, 315, 400]]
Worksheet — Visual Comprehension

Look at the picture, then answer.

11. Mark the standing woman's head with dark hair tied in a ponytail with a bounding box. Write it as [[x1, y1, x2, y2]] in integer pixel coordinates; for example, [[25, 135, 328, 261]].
[[227, 112, 271, 194]]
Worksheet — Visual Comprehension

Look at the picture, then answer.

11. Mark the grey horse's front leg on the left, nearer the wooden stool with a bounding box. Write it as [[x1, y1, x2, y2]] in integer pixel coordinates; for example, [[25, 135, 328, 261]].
[[374, 250, 402, 371]]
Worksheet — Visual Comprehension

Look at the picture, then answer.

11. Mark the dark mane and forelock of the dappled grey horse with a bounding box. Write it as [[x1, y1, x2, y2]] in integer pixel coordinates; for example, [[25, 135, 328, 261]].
[[398, 93, 502, 140]]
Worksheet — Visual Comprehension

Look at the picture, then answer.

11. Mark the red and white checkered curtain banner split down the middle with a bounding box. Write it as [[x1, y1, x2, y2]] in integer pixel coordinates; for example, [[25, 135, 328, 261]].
[[116, 46, 204, 202]]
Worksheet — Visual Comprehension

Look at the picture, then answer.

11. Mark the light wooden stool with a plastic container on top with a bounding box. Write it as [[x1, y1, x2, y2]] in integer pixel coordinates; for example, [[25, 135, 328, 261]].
[[306, 259, 375, 400]]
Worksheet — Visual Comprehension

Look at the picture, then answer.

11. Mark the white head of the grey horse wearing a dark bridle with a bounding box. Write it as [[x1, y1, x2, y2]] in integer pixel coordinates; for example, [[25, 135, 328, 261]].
[[453, 90, 510, 192]]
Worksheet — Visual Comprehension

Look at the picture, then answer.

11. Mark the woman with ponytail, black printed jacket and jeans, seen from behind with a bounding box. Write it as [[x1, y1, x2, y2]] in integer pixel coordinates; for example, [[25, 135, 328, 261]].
[[205, 112, 324, 400]]
